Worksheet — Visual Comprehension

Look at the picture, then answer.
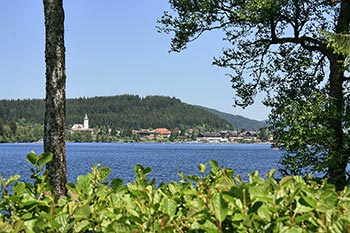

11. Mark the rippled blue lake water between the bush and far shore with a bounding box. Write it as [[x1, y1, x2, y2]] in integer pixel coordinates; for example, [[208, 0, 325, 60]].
[[0, 143, 281, 183]]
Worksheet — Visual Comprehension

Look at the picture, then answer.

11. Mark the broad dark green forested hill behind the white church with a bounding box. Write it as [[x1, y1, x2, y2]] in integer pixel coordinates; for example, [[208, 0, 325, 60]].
[[0, 95, 232, 129]]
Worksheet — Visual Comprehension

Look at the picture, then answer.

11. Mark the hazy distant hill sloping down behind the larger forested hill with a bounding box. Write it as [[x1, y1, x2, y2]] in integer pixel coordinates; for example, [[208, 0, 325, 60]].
[[193, 105, 266, 130]]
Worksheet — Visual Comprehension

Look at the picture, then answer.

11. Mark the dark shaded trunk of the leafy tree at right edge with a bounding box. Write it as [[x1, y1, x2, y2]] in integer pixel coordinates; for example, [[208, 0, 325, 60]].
[[328, 0, 350, 190]]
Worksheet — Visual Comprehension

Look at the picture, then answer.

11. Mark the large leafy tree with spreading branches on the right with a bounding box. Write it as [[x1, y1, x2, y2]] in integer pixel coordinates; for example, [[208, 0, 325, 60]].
[[159, 0, 350, 189]]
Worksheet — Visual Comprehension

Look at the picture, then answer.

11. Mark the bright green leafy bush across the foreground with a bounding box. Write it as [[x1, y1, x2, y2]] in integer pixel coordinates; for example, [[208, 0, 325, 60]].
[[0, 153, 350, 232]]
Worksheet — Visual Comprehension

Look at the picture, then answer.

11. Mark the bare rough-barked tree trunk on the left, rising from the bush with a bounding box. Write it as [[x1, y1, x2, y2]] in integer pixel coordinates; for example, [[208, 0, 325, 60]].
[[43, 0, 67, 197]]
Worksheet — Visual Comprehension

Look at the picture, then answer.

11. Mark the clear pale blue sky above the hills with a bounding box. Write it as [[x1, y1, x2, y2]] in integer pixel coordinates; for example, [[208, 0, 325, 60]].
[[0, 0, 269, 120]]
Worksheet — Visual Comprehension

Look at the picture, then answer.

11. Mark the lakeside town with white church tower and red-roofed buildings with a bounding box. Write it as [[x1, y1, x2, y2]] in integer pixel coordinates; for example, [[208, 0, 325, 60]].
[[67, 114, 273, 143]]
